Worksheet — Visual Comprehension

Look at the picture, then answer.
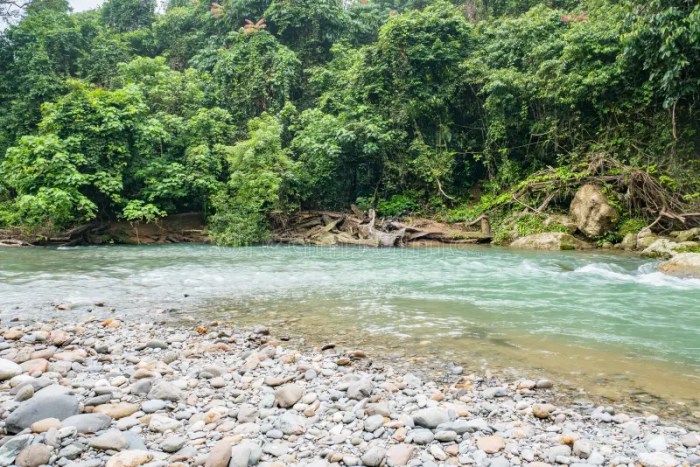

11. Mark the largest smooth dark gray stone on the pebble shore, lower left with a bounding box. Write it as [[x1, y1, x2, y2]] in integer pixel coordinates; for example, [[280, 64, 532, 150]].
[[5, 394, 78, 433]]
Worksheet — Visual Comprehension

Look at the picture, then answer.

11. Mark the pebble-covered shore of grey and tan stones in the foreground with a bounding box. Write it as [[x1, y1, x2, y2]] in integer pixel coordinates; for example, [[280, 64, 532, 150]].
[[0, 319, 700, 467]]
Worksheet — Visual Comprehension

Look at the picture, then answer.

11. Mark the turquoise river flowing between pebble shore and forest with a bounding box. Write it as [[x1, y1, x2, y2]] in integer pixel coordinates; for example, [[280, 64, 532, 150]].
[[0, 245, 700, 421]]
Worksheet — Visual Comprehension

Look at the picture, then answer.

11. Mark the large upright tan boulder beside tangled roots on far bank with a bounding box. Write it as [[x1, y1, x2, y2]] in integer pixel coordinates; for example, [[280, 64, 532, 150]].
[[569, 185, 620, 238]]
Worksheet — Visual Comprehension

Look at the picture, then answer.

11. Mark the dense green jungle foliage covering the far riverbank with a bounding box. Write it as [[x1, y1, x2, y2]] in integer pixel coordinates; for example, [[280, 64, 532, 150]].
[[0, 0, 700, 244]]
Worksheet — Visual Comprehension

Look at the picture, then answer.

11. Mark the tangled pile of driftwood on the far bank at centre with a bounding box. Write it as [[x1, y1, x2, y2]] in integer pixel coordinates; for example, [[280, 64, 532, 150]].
[[272, 205, 491, 247]]
